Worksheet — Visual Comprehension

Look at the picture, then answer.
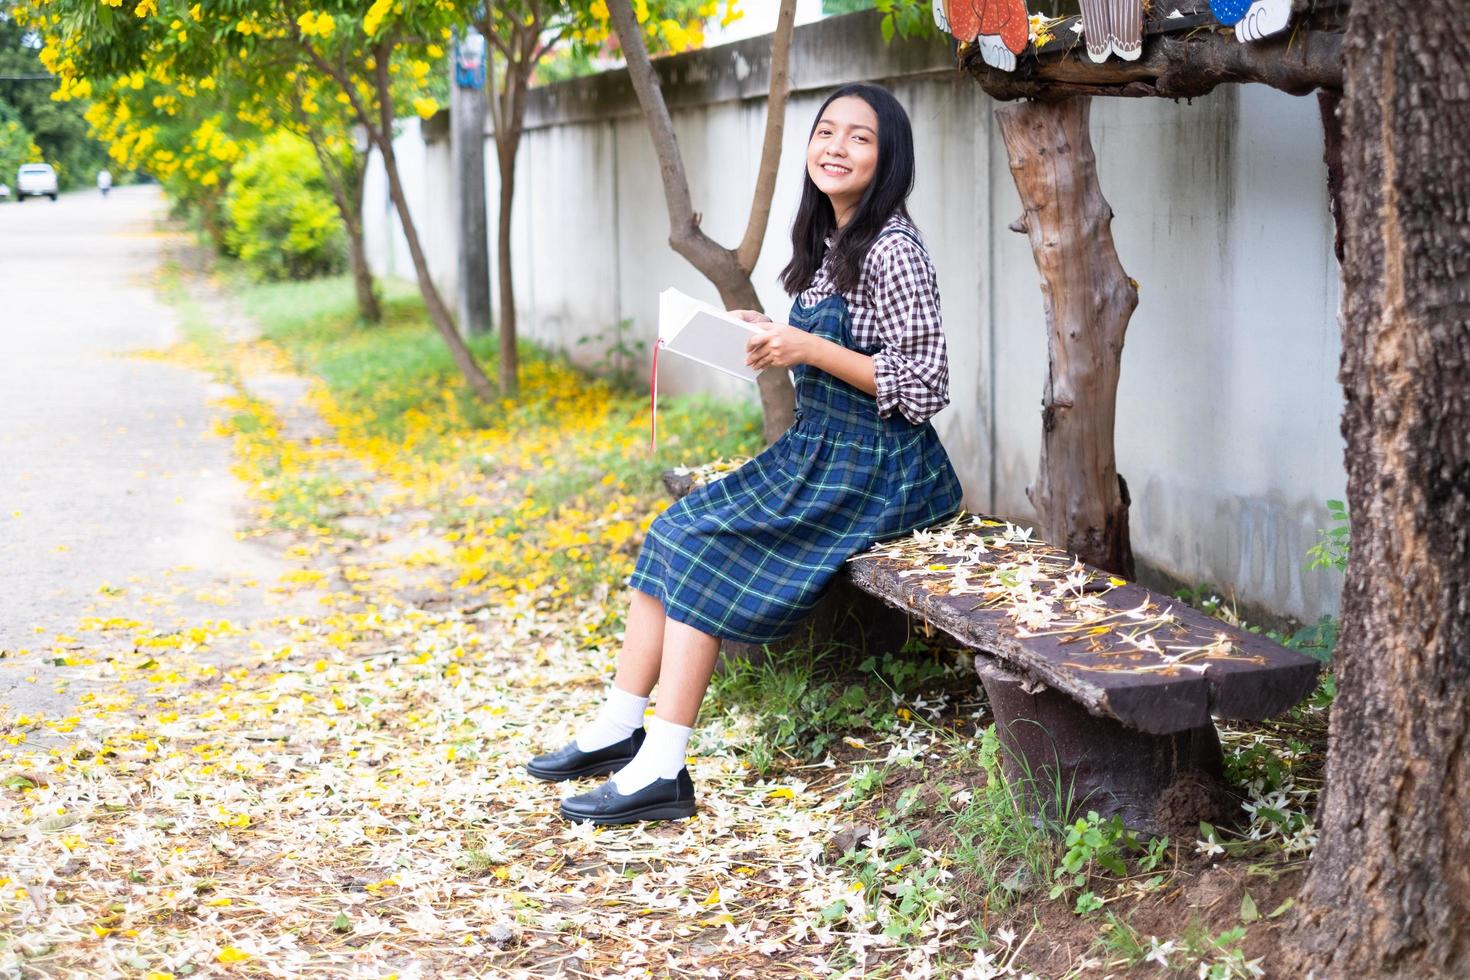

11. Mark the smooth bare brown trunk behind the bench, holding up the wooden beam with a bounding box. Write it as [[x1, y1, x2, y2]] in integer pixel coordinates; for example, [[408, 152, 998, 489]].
[[995, 98, 1138, 577]]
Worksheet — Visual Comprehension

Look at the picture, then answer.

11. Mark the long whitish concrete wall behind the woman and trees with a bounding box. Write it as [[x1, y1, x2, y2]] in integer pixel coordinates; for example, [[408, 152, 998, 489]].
[[368, 15, 1345, 620]]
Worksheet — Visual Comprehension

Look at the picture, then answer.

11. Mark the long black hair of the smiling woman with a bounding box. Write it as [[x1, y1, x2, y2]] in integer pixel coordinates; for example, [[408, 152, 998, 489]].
[[781, 82, 914, 295]]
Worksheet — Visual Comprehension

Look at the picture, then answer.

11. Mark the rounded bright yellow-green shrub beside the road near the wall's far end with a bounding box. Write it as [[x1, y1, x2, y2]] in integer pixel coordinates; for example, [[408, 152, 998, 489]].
[[225, 132, 345, 279]]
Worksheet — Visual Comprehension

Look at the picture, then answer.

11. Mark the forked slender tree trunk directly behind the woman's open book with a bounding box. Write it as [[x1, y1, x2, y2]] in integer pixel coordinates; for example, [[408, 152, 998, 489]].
[[607, 0, 797, 444]]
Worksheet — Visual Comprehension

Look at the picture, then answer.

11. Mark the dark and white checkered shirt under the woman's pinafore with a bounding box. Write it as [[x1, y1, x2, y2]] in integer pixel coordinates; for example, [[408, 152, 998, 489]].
[[797, 215, 950, 425]]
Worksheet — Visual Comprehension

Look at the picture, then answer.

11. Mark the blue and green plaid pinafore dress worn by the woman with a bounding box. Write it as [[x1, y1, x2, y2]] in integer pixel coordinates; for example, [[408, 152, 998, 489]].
[[629, 231, 961, 644]]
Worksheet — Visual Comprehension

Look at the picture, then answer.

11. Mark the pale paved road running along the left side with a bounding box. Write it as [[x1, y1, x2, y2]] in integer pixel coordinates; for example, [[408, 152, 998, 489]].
[[0, 187, 289, 714]]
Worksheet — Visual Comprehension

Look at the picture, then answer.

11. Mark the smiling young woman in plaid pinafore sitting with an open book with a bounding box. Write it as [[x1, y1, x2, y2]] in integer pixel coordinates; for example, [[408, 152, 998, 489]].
[[526, 85, 960, 824]]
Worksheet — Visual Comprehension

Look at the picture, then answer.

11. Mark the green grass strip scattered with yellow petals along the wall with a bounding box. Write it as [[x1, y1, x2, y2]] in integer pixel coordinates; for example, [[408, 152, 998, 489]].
[[234, 278, 760, 507]]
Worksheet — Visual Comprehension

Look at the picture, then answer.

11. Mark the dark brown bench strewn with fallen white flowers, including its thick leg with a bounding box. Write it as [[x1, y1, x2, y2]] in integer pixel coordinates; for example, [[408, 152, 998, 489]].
[[664, 470, 1319, 833]]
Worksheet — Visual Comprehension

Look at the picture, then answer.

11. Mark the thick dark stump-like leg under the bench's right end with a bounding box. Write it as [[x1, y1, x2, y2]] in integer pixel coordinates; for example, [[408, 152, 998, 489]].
[[975, 655, 1226, 836]]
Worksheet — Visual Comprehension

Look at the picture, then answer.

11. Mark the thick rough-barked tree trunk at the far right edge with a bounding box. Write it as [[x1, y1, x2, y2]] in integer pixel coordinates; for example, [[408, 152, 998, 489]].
[[1294, 0, 1470, 977]]
